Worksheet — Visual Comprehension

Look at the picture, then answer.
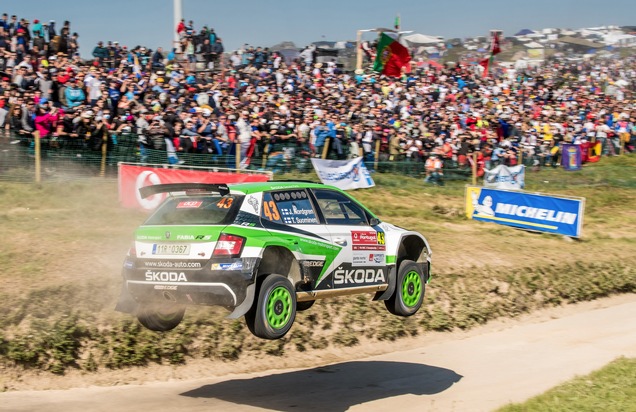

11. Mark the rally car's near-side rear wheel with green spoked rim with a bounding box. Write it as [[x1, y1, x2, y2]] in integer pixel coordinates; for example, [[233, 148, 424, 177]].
[[245, 275, 296, 340]]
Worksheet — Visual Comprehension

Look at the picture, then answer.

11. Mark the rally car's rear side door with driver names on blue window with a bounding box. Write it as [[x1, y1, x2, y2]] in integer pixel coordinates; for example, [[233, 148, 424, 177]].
[[261, 188, 341, 290]]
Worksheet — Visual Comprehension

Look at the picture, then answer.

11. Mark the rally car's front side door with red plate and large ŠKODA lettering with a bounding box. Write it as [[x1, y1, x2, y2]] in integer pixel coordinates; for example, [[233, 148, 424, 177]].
[[312, 189, 388, 288]]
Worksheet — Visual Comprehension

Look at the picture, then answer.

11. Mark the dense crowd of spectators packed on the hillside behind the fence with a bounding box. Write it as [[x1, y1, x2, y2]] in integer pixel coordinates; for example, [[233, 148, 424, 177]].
[[0, 14, 636, 174]]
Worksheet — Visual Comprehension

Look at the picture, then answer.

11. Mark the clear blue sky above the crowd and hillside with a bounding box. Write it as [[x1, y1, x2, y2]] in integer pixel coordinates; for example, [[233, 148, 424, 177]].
[[0, 0, 636, 58]]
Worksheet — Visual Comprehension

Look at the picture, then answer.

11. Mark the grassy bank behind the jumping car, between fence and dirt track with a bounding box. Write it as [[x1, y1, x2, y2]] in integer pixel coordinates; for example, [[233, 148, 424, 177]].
[[0, 156, 636, 376]]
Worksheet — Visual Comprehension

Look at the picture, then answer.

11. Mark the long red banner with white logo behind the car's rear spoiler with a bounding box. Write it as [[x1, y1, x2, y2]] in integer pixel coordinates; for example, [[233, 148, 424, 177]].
[[118, 163, 272, 210]]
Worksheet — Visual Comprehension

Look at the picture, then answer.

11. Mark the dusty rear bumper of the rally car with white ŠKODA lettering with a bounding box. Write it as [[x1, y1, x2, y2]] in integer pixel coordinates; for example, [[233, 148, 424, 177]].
[[116, 258, 260, 312]]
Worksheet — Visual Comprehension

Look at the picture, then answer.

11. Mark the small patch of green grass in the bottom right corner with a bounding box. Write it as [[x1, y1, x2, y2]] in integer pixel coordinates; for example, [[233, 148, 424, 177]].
[[498, 358, 636, 412]]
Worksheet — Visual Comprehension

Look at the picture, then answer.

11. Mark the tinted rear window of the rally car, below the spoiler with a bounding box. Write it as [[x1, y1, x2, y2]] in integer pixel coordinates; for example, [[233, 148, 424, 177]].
[[144, 195, 243, 225]]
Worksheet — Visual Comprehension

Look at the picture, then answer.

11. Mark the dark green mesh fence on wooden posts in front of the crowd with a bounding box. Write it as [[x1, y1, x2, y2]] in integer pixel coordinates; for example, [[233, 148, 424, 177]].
[[0, 131, 473, 182]]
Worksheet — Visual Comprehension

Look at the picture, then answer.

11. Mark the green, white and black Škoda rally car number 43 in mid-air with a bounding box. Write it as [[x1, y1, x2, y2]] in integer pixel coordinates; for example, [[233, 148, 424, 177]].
[[116, 181, 431, 339]]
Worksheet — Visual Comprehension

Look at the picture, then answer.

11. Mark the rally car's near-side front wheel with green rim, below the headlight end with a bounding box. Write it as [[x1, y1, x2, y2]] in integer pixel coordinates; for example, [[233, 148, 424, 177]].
[[384, 260, 426, 316]]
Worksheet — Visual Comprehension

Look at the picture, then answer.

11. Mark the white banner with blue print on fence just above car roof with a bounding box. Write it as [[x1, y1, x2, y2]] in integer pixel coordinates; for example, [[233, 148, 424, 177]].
[[311, 157, 375, 190]]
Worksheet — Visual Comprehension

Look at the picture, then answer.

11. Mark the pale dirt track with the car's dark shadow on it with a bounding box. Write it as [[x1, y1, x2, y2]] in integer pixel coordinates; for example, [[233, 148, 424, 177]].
[[0, 294, 636, 412]]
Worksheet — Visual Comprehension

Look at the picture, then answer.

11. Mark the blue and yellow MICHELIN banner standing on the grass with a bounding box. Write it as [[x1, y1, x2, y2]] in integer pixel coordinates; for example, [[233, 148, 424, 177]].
[[466, 186, 585, 237]]
